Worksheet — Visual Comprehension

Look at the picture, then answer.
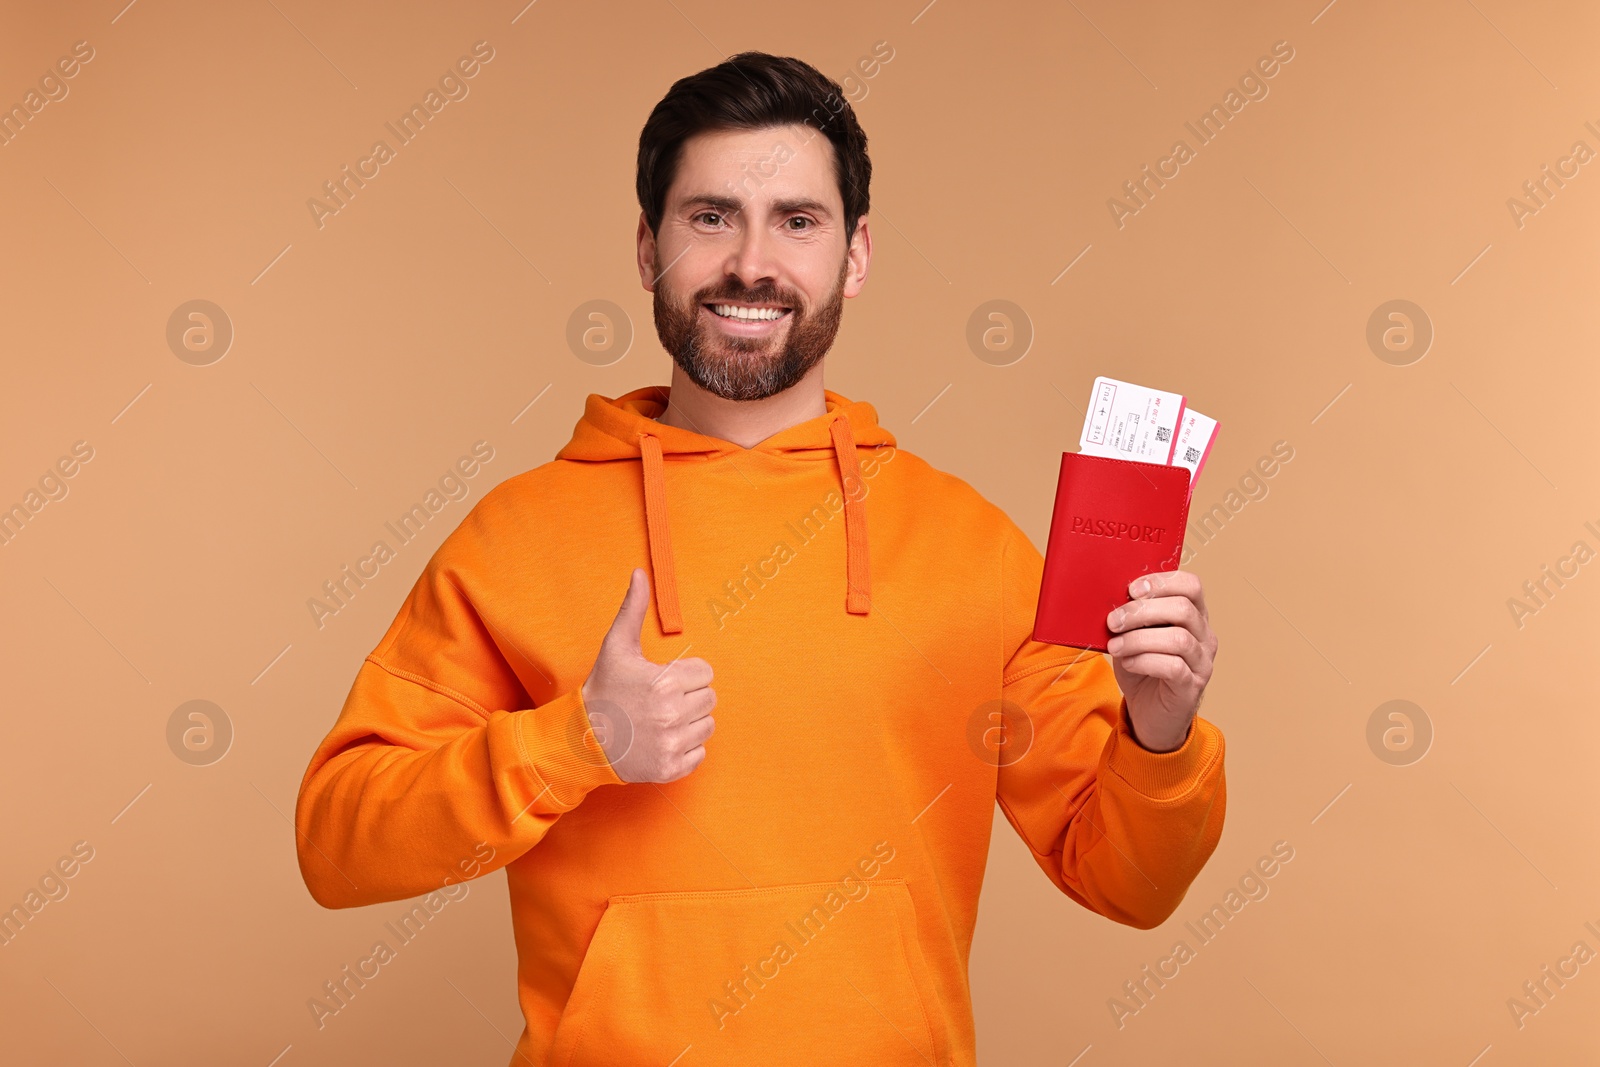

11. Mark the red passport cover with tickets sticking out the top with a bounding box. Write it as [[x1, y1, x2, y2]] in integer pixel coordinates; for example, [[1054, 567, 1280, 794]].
[[1034, 453, 1189, 653]]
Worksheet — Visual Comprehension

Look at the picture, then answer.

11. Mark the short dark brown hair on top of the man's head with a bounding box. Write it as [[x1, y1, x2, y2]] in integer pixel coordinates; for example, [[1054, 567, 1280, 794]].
[[634, 51, 872, 240]]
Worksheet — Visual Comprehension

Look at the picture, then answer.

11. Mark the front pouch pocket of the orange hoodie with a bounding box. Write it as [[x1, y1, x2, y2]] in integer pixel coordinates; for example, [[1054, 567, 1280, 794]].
[[550, 878, 949, 1067]]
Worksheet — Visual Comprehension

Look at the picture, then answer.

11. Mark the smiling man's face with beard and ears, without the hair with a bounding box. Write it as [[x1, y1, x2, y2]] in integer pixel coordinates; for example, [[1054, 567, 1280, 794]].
[[638, 126, 872, 400]]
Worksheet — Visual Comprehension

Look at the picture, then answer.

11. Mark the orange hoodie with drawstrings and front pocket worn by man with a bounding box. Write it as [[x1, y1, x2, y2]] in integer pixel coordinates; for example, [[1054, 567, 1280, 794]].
[[296, 387, 1224, 1067]]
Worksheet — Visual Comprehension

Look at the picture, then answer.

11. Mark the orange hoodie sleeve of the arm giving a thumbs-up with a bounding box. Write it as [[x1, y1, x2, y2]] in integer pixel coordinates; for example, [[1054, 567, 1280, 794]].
[[294, 498, 622, 907]]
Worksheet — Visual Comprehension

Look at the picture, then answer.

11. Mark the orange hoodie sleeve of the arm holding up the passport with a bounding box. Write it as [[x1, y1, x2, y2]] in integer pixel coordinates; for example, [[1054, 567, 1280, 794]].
[[997, 520, 1227, 929]]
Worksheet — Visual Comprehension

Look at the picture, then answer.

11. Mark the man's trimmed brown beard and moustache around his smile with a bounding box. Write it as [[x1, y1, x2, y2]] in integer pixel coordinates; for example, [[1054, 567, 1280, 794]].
[[653, 253, 850, 400]]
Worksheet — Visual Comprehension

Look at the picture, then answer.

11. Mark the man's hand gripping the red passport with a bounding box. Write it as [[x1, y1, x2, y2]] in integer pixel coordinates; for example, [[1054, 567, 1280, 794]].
[[1106, 571, 1216, 752]]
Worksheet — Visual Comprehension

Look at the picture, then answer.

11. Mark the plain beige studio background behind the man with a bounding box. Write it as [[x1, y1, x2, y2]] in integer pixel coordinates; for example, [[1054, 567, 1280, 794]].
[[0, 0, 1600, 1067]]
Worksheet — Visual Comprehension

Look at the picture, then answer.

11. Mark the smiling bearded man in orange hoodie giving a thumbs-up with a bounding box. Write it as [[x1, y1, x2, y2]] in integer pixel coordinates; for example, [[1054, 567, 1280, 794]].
[[296, 53, 1224, 1067]]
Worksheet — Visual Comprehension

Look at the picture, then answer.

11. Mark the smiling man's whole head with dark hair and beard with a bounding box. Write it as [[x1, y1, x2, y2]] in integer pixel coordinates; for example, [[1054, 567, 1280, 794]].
[[637, 53, 872, 400]]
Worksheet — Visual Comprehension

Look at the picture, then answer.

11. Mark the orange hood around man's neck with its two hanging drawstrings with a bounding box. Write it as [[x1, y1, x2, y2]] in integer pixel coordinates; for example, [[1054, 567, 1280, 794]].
[[555, 386, 894, 633]]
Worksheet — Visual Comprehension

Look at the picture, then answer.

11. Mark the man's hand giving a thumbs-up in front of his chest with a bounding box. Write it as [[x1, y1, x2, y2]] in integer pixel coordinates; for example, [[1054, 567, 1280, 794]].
[[582, 566, 717, 782]]
